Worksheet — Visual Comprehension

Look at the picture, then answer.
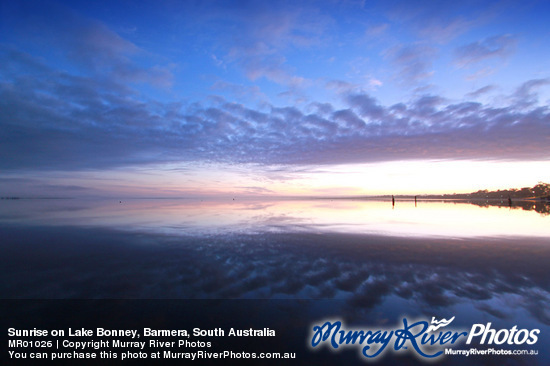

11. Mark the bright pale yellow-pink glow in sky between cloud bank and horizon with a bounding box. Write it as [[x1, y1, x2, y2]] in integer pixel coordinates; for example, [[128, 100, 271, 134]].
[[10, 161, 550, 197]]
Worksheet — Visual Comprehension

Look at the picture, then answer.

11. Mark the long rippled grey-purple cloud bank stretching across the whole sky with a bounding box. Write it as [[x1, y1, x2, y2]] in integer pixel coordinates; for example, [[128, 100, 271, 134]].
[[0, 48, 550, 170]]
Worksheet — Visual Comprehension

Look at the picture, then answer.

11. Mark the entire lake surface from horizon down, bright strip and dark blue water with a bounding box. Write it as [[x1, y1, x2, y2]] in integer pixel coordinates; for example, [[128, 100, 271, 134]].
[[0, 198, 550, 365]]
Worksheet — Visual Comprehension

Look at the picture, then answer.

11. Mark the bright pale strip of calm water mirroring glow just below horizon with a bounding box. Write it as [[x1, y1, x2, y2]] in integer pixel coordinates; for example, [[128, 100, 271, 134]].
[[0, 199, 550, 238]]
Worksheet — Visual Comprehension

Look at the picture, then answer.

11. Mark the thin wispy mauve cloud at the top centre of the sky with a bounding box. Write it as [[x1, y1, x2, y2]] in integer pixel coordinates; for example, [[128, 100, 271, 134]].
[[208, 1, 332, 88]]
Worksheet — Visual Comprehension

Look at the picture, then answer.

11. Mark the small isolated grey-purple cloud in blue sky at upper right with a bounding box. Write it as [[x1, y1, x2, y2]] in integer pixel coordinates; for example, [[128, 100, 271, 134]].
[[454, 34, 517, 67]]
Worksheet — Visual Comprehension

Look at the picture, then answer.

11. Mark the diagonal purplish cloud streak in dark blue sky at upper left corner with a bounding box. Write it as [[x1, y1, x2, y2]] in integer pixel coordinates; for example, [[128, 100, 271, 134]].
[[3, 2, 174, 88]]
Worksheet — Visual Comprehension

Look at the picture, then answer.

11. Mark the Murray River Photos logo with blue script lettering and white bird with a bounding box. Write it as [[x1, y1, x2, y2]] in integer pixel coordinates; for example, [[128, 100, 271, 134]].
[[310, 316, 540, 359]]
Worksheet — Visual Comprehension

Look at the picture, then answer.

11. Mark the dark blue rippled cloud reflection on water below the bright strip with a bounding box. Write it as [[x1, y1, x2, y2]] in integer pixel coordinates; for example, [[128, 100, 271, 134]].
[[1, 227, 550, 325]]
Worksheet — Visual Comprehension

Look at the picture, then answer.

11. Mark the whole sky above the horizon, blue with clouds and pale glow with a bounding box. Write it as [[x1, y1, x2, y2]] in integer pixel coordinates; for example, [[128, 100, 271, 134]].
[[0, 0, 550, 197]]
